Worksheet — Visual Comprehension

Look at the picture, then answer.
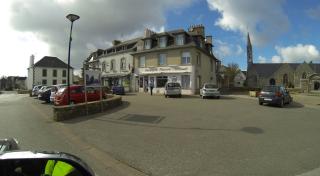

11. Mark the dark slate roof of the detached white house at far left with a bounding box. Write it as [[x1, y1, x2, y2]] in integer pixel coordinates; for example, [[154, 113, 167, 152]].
[[34, 56, 72, 68]]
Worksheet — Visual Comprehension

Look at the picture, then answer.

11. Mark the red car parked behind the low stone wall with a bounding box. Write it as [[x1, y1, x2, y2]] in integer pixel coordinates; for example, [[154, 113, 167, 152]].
[[54, 85, 100, 106]]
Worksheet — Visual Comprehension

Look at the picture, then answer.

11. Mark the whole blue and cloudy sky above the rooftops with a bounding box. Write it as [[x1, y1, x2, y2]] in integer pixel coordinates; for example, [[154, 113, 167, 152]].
[[0, 0, 320, 76]]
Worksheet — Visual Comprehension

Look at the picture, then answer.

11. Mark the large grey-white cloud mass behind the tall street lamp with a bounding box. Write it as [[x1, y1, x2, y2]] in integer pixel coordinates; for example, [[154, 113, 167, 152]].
[[0, 0, 194, 75]]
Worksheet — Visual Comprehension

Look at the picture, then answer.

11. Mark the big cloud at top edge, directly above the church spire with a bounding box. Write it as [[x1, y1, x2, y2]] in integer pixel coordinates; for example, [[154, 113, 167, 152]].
[[207, 0, 289, 45]]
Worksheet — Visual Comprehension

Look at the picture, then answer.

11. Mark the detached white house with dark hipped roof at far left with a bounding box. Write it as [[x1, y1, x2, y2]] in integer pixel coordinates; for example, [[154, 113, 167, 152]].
[[27, 55, 73, 89]]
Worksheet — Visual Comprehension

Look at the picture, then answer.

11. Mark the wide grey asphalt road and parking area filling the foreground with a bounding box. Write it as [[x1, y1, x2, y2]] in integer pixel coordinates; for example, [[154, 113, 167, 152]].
[[0, 94, 320, 176]]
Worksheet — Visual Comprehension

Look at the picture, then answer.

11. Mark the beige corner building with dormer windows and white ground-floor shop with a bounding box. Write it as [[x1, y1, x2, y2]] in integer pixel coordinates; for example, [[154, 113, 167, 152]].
[[132, 25, 218, 94]]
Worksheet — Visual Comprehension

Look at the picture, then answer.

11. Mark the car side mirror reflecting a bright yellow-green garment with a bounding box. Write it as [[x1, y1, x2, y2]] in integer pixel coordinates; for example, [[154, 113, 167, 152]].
[[0, 151, 94, 176]]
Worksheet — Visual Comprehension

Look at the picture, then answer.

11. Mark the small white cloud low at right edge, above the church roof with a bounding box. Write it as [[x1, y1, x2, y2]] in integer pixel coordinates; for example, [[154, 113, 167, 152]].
[[275, 44, 320, 63]]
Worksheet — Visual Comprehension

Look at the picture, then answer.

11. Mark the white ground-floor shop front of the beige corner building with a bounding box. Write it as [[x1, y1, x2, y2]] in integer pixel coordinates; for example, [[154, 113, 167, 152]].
[[136, 66, 195, 95]]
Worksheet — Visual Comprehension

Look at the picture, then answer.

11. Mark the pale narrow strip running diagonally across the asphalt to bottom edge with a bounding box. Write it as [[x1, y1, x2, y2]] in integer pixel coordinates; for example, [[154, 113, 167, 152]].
[[29, 100, 151, 176]]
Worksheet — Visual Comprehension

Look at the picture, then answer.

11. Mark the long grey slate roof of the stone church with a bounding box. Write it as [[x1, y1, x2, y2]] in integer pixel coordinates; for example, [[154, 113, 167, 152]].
[[250, 63, 320, 77]]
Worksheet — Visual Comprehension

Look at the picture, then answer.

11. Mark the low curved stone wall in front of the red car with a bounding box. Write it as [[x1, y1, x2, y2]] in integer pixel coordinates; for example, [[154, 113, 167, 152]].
[[53, 96, 122, 121]]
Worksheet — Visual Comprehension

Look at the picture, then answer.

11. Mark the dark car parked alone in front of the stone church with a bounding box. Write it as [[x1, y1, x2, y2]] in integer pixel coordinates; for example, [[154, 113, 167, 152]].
[[258, 85, 293, 107]]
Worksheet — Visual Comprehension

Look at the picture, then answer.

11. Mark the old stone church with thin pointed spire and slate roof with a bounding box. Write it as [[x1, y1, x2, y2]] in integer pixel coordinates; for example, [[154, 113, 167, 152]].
[[247, 34, 320, 92]]
